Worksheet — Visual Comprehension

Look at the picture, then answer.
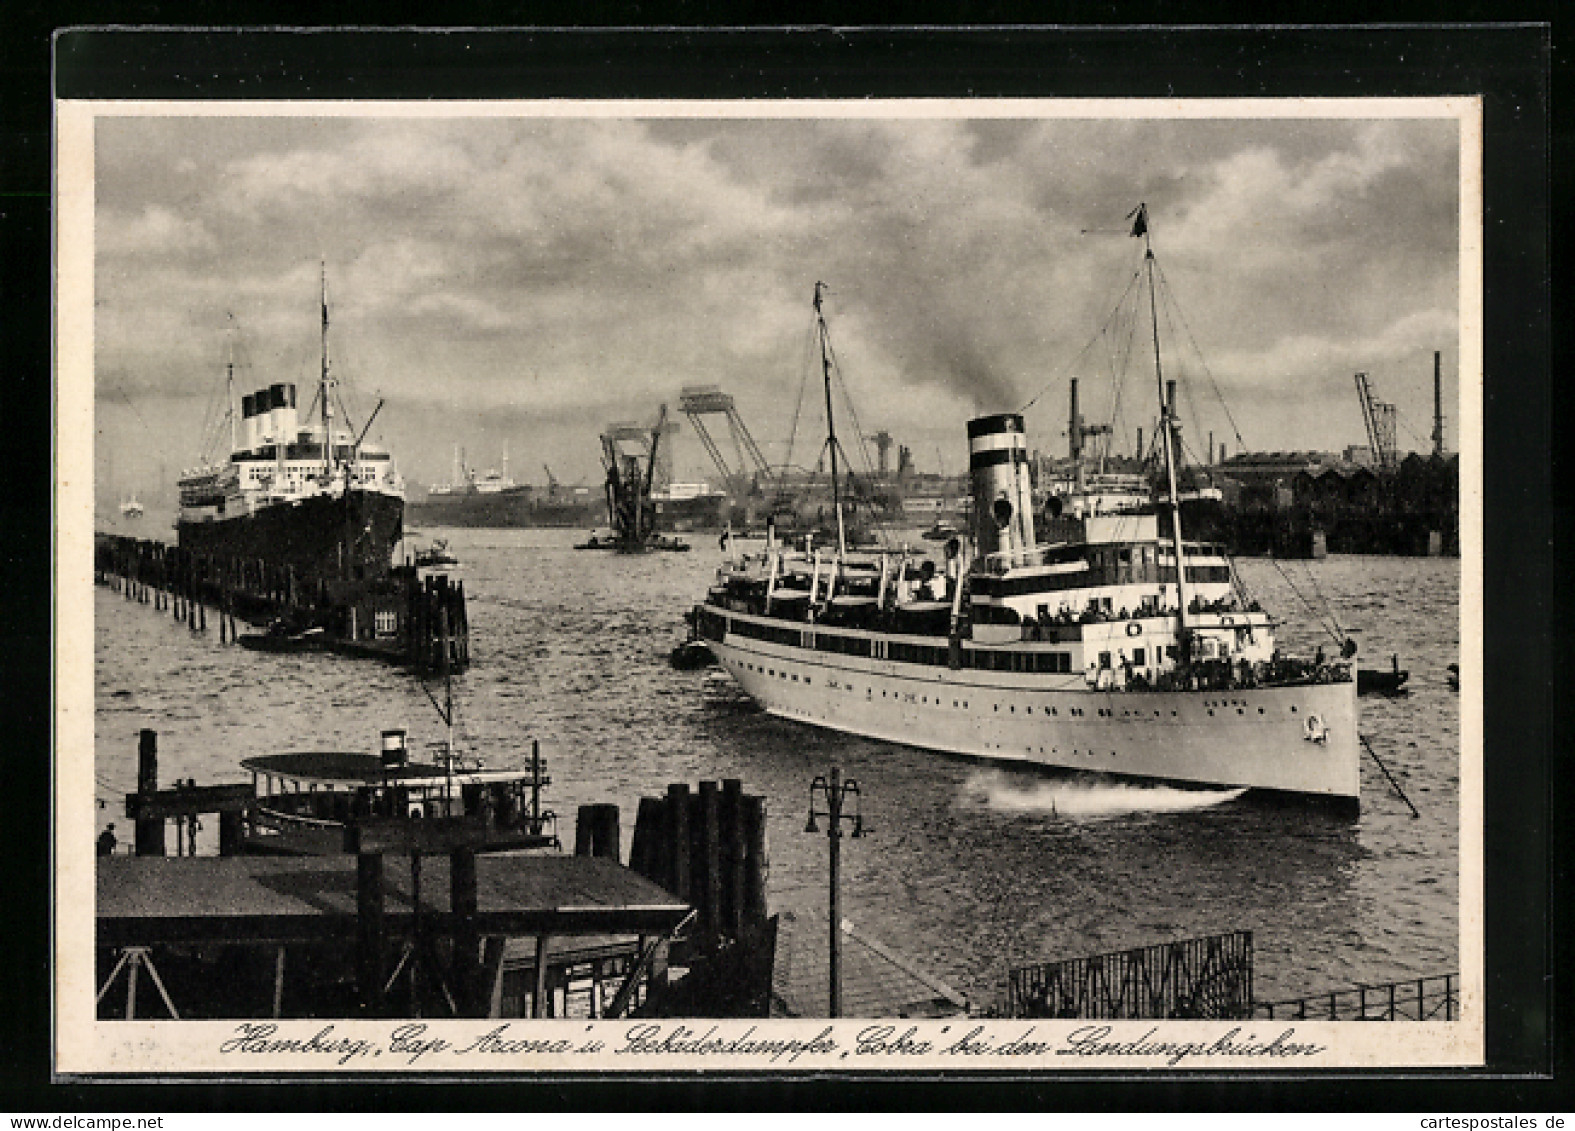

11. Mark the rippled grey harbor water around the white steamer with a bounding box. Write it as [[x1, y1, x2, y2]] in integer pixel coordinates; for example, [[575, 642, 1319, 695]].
[[95, 529, 1460, 1007]]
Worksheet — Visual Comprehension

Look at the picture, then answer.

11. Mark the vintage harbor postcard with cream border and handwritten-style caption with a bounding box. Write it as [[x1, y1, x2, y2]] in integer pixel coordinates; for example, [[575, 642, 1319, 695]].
[[57, 99, 1484, 1074]]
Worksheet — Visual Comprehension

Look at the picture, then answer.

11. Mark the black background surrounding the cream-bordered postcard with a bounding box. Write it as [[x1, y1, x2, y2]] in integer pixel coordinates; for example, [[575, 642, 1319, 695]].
[[0, 15, 1570, 1118]]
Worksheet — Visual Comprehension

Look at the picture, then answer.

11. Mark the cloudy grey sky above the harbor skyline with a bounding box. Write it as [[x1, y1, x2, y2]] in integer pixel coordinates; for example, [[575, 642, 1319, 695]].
[[95, 107, 1458, 502]]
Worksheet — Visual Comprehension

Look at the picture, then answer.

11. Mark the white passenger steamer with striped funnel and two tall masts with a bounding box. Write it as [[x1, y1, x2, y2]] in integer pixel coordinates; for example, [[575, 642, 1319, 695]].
[[691, 206, 1359, 810]]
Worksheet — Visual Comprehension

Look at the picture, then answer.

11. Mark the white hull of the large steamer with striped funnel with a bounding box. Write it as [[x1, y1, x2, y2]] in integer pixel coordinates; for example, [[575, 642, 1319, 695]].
[[706, 633, 1359, 803]]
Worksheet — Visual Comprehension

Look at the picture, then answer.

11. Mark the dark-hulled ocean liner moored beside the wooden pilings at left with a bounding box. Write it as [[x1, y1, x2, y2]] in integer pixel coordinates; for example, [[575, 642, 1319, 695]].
[[176, 273, 405, 584]]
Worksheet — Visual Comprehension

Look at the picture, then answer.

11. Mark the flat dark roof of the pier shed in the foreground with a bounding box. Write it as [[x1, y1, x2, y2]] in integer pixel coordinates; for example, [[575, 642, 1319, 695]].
[[96, 855, 688, 947]]
